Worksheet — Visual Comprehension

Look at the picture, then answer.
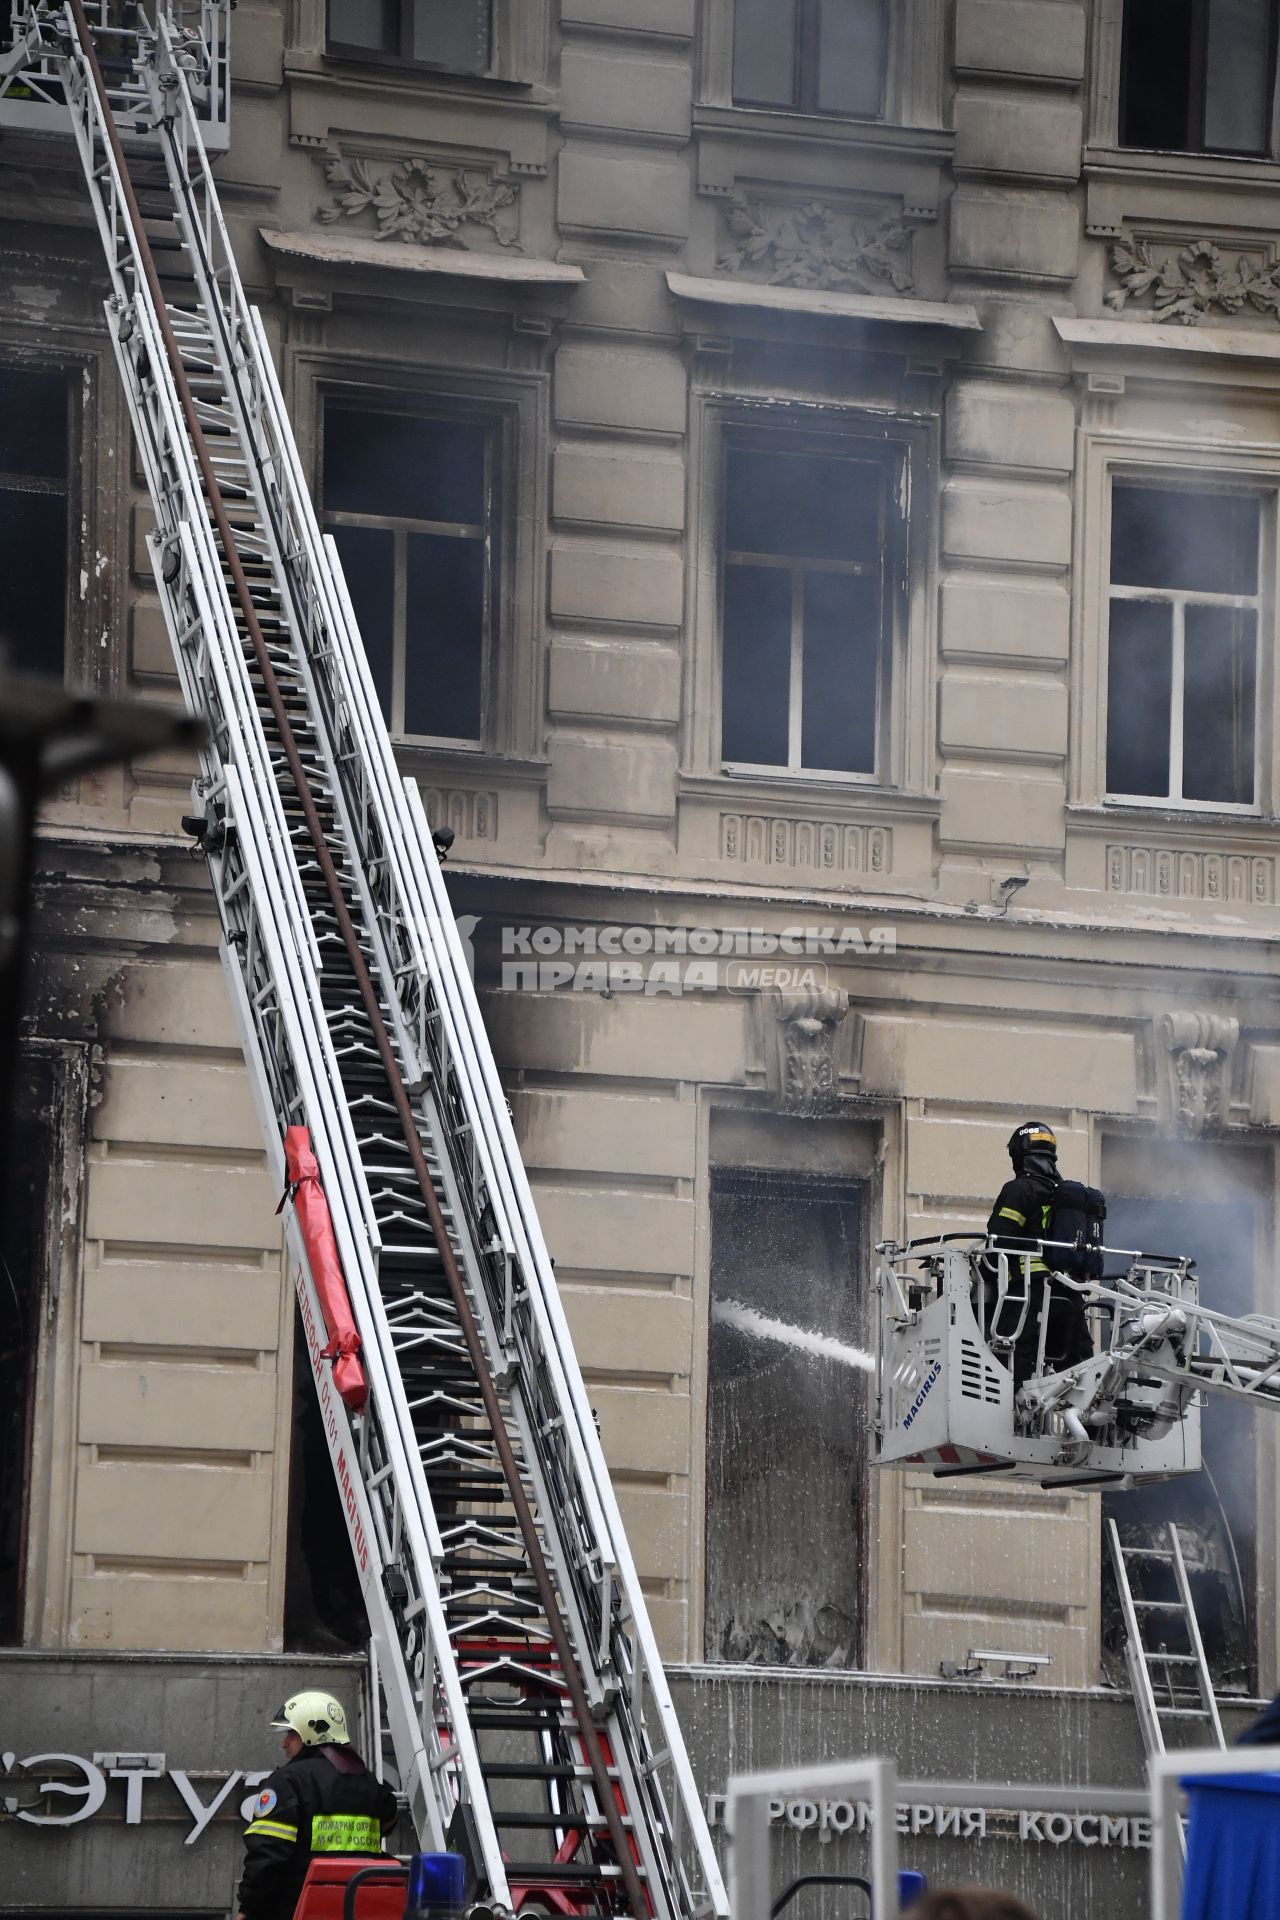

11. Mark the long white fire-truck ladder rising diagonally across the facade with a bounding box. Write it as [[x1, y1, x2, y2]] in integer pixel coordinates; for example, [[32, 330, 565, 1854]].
[[0, 0, 727, 1920]]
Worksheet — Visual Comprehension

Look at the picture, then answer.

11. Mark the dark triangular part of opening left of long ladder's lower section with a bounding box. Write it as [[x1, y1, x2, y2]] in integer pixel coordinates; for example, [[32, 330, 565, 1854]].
[[284, 1313, 368, 1653]]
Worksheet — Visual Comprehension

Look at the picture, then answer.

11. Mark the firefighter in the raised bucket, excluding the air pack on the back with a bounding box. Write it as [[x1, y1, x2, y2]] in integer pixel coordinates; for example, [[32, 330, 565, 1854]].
[[986, 1121, 1094, 1384]]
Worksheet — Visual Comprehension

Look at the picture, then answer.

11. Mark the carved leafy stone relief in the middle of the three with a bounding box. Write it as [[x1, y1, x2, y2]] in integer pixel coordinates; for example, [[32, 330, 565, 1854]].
[[716, 192, 915, 294]]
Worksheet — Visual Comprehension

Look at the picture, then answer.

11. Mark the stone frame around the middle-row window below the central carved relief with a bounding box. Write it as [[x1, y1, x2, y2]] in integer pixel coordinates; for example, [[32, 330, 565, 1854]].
[[681, 394, 936, 801]]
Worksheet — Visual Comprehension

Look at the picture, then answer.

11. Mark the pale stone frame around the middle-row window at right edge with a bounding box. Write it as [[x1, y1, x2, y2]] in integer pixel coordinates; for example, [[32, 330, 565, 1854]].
[[1071, 430, 1280, 829]]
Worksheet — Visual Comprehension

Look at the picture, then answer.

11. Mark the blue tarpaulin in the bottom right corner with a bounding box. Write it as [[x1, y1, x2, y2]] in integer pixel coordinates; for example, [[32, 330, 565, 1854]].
[[1182, 1772, 1280, 1920]]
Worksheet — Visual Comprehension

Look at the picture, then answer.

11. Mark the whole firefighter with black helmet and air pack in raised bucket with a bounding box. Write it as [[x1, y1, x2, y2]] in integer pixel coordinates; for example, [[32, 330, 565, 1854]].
[[984, 1119, 1107, 1386]]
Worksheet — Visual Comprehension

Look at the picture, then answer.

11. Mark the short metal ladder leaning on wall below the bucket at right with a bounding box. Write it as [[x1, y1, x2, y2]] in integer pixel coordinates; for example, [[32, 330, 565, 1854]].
[[1107, 1521, 1226, 1759]]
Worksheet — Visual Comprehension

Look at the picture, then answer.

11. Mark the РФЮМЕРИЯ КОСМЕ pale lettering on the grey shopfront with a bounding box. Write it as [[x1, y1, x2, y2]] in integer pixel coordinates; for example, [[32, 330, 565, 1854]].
[[706, 1793, 1151, 1851]]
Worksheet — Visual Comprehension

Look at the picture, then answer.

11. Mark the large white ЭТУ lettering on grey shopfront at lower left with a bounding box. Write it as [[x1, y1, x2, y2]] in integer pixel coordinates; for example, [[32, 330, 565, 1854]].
[[0, 1753, 271, 1847]]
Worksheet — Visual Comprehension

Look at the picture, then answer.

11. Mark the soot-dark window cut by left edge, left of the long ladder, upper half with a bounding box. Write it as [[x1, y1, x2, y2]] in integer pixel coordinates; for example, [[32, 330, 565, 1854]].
[[0, 367, 71, 678]]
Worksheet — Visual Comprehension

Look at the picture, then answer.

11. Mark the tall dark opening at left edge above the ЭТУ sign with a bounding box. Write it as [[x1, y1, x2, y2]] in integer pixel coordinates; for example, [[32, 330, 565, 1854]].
[[0, 1056, 58, 1647]]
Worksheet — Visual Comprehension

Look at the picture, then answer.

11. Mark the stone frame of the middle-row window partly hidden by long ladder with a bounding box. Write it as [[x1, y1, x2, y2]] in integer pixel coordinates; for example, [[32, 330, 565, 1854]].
[[294, 349, 549, 768]]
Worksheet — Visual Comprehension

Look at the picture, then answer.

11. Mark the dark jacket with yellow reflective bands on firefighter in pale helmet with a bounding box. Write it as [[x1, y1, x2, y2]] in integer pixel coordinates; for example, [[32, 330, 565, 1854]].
[[240, 1745, 397, 1920]]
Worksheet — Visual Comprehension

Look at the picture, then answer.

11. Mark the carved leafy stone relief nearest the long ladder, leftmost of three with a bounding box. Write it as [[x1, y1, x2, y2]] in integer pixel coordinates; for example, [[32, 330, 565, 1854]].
[[317, 154, 520, 250]]
